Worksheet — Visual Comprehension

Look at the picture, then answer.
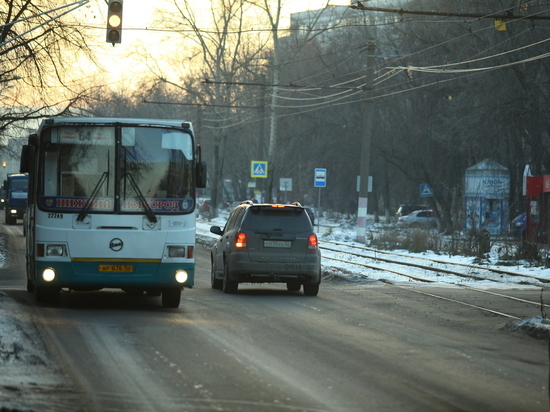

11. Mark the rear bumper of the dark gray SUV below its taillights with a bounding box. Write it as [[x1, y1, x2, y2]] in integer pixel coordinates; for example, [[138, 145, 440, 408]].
[[227, 254, 321, 283]]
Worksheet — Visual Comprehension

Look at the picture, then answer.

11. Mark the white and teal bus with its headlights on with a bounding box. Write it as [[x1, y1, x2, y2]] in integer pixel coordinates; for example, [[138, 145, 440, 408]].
[[21, 117, 206, 307]]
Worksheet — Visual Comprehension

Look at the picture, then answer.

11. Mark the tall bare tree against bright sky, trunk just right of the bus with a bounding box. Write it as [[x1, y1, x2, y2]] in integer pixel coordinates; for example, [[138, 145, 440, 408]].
[[143, 0, 272, 217]]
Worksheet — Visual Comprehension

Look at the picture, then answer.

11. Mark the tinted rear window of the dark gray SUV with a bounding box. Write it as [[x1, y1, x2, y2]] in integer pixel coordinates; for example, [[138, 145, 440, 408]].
[[242, 206, 312, 233]]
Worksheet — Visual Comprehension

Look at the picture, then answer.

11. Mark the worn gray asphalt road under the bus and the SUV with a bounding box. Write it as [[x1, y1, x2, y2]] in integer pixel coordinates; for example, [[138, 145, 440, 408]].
[[0, 220, 549, 412]]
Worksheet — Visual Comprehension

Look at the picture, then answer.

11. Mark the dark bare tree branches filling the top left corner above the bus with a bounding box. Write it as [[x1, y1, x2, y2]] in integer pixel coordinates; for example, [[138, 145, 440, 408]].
[[0, 0, 97, 137]]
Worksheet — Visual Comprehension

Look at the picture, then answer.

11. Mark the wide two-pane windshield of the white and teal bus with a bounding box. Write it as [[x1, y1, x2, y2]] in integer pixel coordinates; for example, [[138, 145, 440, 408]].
[[38, 125, 194, 214]]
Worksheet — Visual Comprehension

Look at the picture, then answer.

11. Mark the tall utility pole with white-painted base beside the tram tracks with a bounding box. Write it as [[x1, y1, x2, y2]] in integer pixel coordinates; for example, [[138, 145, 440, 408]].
[[356, 40, 376, 243]]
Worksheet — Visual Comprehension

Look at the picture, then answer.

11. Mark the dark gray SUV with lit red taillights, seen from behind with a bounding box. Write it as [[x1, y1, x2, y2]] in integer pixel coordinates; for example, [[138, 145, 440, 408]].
[[210, 201, 321, 296]]
